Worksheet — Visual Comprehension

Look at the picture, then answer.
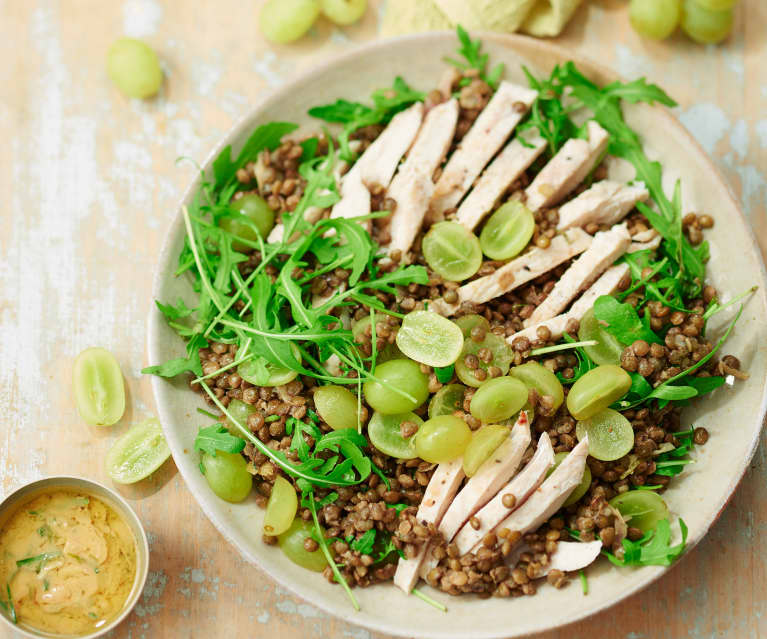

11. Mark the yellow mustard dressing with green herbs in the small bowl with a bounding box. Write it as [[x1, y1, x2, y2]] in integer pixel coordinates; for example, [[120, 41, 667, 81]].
[[0, 489, 136, 635]]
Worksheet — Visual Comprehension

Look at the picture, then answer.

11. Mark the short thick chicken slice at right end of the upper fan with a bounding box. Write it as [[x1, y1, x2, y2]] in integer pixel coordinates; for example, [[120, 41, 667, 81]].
[[557, 180, 650, 230]]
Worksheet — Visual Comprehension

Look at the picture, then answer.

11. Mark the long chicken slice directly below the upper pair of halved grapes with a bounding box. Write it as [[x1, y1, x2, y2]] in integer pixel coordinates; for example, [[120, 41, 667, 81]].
[[429, 228, 592, 316]]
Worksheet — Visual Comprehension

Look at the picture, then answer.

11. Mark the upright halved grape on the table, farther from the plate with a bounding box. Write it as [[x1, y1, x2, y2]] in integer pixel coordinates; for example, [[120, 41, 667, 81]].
[[72, 348, 125, 426]]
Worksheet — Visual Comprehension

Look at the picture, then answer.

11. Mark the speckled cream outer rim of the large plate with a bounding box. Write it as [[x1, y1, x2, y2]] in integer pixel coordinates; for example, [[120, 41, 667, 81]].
[[147, 32, 767, 639]]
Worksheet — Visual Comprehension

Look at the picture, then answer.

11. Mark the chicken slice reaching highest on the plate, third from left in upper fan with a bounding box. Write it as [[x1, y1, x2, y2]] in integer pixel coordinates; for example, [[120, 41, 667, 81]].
[[429, 82, 538, 222]]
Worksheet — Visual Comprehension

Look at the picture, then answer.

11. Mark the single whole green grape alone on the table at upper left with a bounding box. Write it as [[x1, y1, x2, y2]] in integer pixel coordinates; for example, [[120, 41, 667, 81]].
[[107, 38, 162, 98]]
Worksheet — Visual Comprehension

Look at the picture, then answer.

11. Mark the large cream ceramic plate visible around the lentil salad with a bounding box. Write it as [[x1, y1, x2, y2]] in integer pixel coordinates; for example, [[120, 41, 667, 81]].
[[148, 33, 767, 639]]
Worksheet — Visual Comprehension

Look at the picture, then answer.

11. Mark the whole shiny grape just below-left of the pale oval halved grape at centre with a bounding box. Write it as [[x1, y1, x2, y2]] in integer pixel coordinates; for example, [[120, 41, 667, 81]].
[[364, 359, 429, 415]]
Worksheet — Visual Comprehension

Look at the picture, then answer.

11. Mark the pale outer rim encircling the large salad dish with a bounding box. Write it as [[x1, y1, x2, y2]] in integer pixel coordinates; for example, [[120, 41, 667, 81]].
[[147, 31, 767, 639]]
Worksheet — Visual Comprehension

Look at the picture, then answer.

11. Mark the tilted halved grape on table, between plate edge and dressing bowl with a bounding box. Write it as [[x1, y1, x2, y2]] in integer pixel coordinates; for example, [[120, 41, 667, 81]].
[[106, 417, 170, 484]]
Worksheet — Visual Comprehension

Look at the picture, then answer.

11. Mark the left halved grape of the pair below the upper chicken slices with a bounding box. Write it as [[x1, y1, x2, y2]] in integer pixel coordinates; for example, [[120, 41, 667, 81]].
[[421, 222, 482, 282]]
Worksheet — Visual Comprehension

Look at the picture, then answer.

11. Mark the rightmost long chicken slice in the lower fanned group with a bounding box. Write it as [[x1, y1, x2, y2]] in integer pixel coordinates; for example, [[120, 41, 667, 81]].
[[488, 437, 589, 552]]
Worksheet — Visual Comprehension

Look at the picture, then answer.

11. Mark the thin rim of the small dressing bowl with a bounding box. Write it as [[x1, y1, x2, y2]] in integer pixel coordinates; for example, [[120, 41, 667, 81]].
[[0, 475, 149, 639]]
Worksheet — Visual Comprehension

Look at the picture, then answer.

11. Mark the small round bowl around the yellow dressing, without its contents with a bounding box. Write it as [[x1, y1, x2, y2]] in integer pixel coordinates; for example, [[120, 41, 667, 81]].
[[0, 476, 149, 639]]
